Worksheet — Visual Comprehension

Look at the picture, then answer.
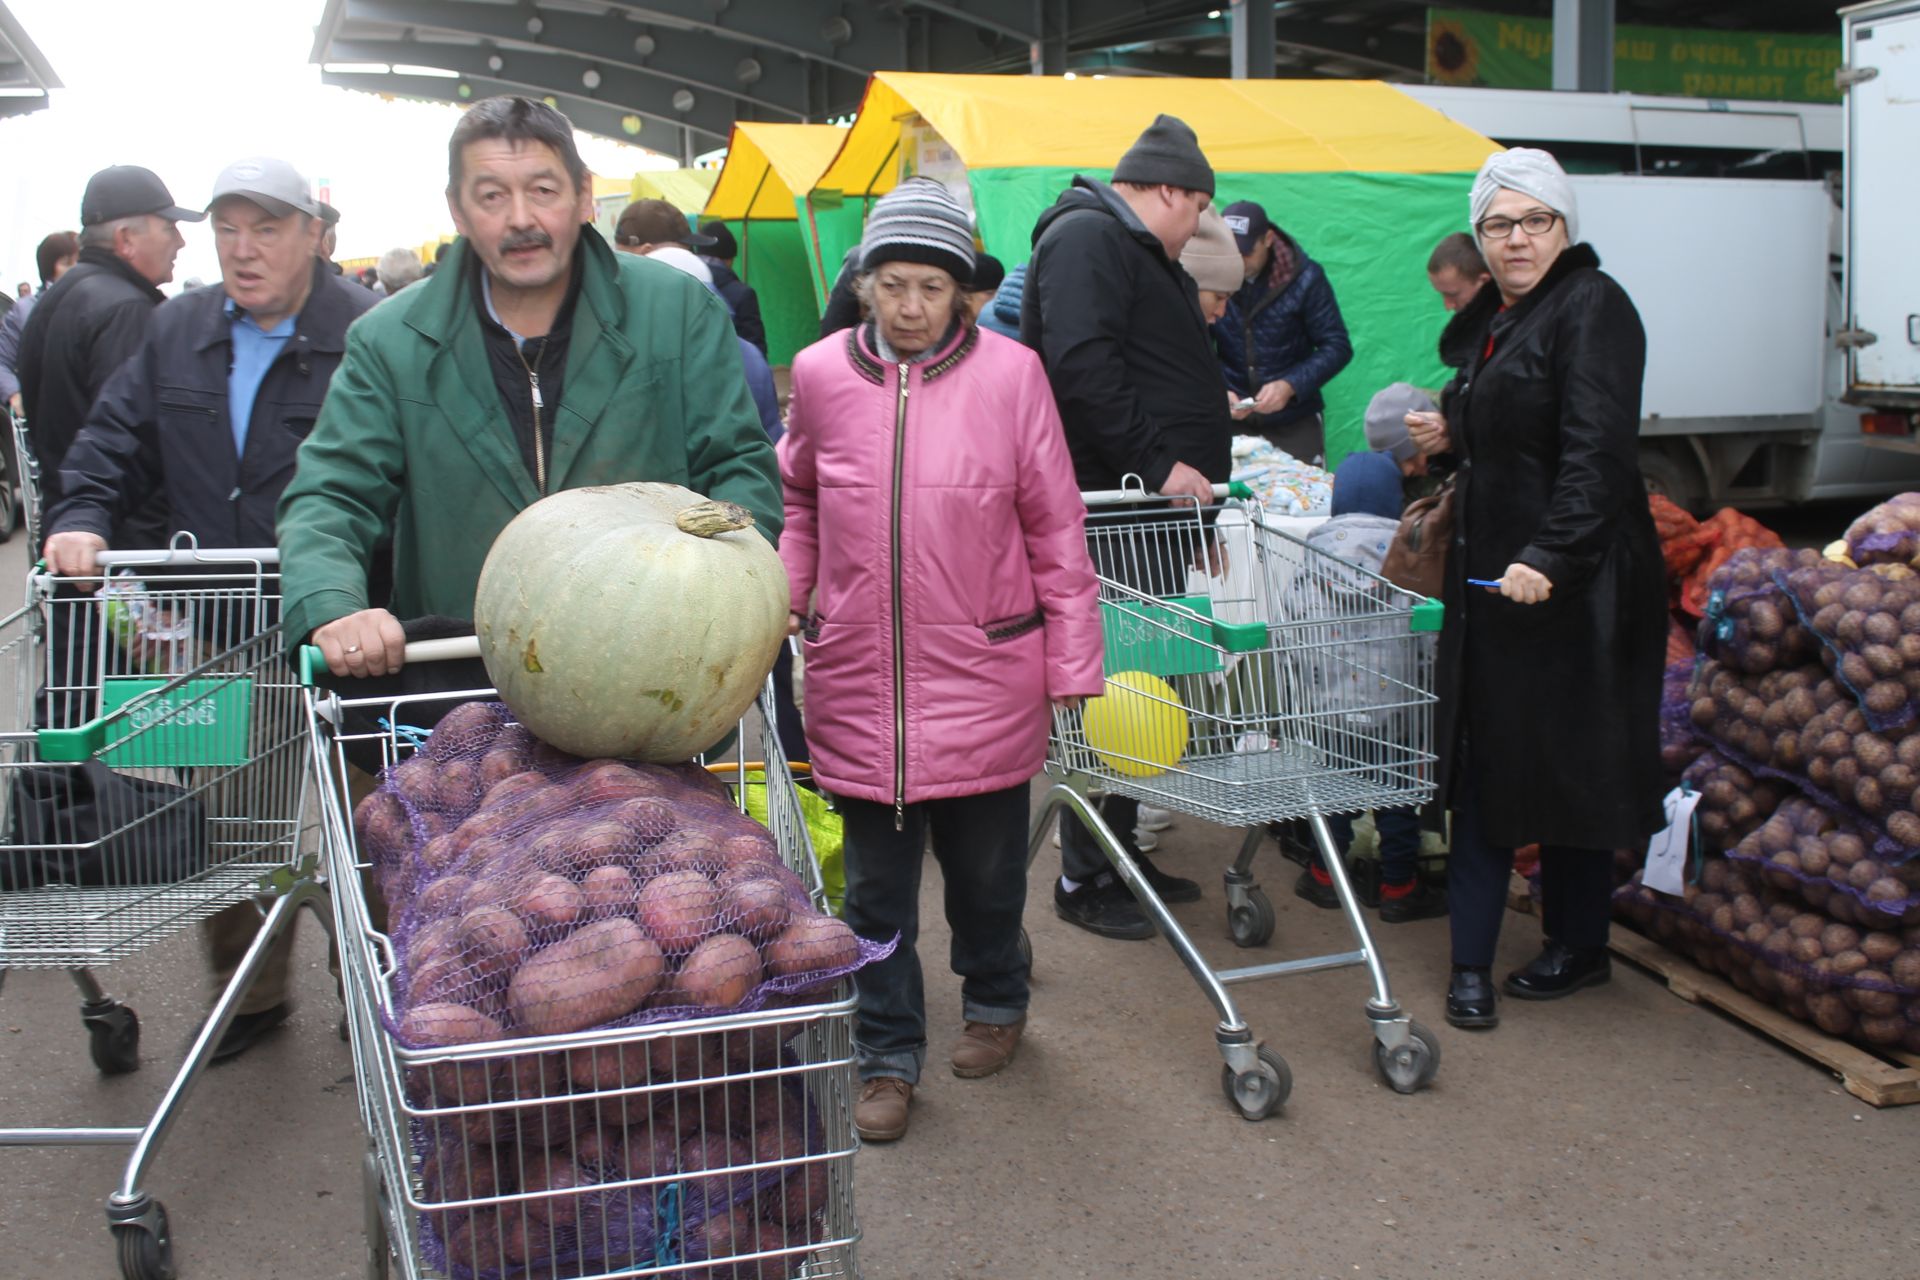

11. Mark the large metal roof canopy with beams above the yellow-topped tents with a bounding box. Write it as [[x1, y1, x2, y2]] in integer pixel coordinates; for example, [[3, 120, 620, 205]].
[[313, 0, 1837, 159]]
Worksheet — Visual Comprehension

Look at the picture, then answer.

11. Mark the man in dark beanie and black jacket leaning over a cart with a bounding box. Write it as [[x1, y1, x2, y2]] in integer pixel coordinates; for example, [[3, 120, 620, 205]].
[[1020, 115, 1233, 938]]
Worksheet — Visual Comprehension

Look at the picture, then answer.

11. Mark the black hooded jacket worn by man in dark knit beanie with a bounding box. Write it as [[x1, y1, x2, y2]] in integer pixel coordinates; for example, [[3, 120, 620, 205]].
[[1020, 178, 1233, 489]]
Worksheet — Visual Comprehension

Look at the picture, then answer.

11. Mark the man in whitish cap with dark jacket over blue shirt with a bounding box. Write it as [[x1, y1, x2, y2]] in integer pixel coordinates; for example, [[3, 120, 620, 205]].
[[46, 157, 378, 1061]]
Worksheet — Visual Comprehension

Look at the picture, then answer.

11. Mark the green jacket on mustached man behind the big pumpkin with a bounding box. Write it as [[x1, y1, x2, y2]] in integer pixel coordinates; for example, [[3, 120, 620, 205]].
[[278, 230, 781, 643]]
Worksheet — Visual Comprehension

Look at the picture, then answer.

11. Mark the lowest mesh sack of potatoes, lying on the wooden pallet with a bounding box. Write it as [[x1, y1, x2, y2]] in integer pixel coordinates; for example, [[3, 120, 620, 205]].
[[1615, 858, 1920, 1052]]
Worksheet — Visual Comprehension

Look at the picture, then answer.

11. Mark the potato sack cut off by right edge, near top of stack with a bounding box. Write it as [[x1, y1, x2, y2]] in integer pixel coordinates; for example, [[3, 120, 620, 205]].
[[1784, 560, 1920, 731]]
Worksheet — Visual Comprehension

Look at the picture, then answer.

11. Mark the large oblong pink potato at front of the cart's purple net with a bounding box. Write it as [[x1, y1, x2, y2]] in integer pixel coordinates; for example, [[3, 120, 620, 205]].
[[507, 917, 666, 1036]]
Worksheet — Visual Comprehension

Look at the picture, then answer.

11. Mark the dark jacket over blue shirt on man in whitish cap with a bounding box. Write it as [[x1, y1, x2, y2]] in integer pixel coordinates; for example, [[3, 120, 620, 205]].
[[48, 259, 380, 547]]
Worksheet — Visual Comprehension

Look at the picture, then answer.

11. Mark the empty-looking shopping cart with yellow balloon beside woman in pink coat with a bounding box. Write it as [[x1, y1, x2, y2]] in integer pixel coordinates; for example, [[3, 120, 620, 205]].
[[1027, 486, 1440, 1121]]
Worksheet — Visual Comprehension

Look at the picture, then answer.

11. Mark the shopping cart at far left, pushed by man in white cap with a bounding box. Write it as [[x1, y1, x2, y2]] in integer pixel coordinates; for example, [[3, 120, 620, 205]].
[[0, 537, 330, 1280]]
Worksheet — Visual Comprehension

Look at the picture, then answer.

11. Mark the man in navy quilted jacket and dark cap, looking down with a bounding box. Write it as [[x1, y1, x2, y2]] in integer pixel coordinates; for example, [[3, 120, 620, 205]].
[[1213, 200, 1354, 462]]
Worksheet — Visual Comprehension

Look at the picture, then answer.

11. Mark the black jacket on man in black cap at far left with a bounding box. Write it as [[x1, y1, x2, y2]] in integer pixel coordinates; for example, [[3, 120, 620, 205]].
[[15, 248, 167, 521]]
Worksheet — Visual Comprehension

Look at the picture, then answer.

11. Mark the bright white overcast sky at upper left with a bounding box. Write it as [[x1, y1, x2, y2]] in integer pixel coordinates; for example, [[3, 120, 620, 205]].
[[0, 0, 666, 294]]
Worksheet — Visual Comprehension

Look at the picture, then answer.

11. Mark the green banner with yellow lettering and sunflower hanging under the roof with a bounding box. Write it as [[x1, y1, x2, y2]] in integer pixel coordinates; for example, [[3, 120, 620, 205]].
[[1427, 10, 1841, 102]]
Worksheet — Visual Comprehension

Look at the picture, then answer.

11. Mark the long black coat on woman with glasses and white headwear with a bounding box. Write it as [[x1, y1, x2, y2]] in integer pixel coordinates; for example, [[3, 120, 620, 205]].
[[1436, 244, 1667, 848]]
